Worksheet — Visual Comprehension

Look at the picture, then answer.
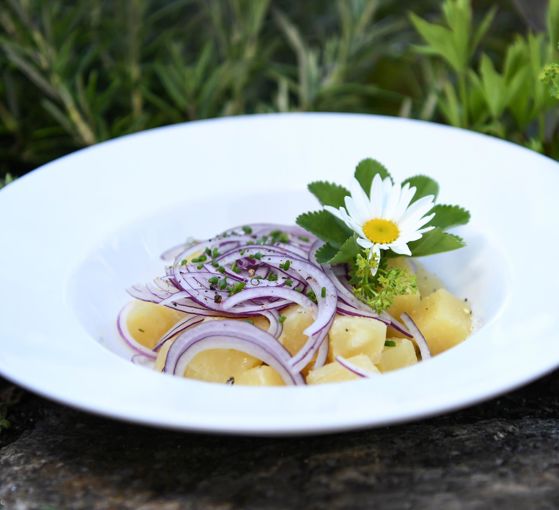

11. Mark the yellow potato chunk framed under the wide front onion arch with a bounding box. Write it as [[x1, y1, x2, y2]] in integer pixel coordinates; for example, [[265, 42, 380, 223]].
[[184, 349, 262, 383]]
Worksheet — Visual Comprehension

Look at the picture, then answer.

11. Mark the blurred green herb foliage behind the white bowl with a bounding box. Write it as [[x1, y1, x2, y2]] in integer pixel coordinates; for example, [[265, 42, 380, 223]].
[[0, 0, 559, 182]]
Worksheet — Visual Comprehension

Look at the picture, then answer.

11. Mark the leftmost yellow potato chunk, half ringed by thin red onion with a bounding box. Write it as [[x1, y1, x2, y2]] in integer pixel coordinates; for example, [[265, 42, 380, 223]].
[[126, 301, 186, 349]]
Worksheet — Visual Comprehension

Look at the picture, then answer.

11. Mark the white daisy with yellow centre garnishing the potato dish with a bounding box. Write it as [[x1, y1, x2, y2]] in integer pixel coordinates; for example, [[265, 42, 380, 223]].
[[324, 174, 435, 266]]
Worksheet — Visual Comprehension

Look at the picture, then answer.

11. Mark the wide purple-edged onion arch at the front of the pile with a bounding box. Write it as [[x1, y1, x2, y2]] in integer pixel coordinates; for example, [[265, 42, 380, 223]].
[[163, 320, 305, 385]]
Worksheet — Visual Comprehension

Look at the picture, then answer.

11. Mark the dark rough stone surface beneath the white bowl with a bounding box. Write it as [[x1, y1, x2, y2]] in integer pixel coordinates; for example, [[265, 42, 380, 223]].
[[0, 371, 559, 510]]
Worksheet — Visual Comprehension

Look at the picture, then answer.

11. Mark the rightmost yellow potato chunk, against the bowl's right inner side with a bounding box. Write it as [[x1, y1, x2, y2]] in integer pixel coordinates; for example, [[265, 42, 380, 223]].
[[411, 289, 472, 354]]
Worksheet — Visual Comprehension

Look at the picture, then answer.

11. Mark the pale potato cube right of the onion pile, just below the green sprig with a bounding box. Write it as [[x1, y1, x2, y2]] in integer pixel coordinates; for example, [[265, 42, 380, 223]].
[[328, 315, 386, 363]]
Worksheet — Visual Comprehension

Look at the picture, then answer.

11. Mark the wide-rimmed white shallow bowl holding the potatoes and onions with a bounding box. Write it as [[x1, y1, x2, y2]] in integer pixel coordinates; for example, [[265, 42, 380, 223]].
[[0, 114, 559, 434]]
